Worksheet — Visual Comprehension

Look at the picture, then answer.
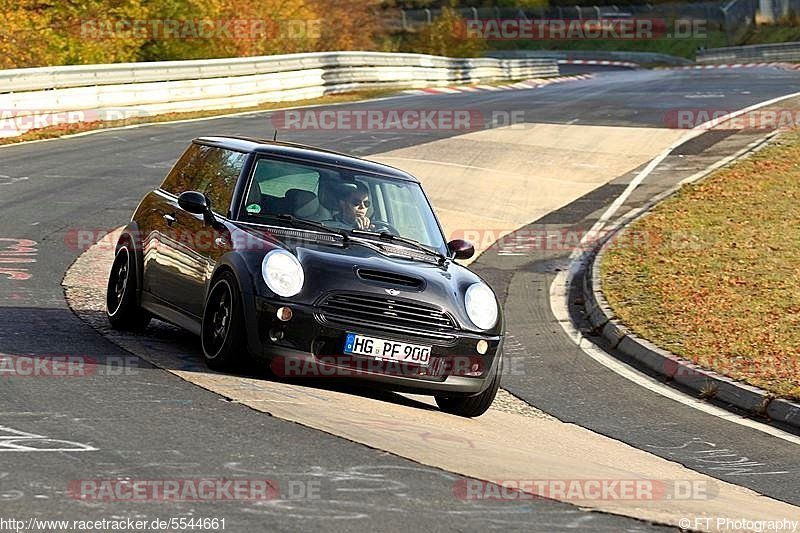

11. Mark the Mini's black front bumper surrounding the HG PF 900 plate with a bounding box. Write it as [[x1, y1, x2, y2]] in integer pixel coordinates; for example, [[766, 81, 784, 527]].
[[243, 295, 503, 394]]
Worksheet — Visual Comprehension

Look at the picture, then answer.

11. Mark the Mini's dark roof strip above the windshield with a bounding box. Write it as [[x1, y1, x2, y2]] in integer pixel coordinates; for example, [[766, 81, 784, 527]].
[[194, 135, 419, 183]]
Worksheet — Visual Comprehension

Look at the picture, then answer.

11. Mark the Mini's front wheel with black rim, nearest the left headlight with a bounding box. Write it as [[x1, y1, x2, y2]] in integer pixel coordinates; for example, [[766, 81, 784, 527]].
[[200, 272, 247, 371]]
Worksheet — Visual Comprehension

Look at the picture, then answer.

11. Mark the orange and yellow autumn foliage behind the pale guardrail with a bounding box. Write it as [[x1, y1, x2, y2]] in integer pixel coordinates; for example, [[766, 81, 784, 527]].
[[0, 0, 432, 68]]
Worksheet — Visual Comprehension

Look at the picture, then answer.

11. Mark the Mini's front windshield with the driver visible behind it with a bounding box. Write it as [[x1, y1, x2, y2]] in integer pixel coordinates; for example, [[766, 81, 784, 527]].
[[239, 158, 446, 253]]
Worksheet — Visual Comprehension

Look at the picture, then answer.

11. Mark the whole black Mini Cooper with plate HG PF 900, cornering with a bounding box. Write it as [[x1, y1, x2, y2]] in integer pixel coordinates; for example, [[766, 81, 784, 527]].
[[106, 137, 503, 416]]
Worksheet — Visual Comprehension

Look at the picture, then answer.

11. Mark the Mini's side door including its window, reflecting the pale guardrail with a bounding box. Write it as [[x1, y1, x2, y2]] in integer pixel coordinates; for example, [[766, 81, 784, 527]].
[[151, 143, 247, 320]]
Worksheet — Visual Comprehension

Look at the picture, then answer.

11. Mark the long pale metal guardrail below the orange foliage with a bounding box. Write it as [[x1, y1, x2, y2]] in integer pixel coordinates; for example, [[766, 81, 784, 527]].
[[0, 52, 558, 137]]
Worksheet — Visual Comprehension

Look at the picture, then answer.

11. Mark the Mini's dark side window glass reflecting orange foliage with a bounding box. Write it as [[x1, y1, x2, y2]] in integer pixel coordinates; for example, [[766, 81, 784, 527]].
[[161, 144, 247, 215]]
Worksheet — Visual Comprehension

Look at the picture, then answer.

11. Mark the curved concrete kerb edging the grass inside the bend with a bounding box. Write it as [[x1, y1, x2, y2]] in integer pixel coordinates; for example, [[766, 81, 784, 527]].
[[581, 134, 800, 428]]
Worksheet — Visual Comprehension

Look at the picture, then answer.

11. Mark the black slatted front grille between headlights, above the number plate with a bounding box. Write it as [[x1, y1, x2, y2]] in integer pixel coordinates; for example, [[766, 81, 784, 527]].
[[320, 293, 455, 333]]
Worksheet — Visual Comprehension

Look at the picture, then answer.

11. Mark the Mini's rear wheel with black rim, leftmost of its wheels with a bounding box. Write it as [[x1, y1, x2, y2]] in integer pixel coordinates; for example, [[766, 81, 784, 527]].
[[106, 240, 152, 331]]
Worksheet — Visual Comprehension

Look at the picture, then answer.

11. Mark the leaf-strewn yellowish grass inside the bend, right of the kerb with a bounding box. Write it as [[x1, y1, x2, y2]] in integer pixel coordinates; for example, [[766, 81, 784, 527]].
[[600, 131, 800, 400]]
